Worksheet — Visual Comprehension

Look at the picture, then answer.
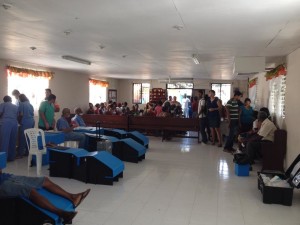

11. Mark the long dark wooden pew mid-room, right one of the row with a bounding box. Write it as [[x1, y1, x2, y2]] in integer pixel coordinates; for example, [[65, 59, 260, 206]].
[[128, 116, 200, 143]]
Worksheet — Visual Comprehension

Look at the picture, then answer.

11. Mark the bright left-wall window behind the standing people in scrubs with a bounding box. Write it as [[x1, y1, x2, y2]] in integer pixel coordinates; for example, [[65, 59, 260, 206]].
[[7, 72, 49, 110]]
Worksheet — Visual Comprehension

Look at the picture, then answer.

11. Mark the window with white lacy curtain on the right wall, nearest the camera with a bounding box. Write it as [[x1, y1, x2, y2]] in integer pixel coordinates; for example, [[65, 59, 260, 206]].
[[269, 76, 286, 118]]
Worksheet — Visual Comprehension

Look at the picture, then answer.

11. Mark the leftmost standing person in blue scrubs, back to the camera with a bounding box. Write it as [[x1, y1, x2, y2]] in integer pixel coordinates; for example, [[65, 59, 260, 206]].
[[0, 96, 18, 161]]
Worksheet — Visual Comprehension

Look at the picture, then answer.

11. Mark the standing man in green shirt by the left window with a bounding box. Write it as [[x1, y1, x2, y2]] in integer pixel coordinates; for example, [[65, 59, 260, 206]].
[[39, 94, 56, 130]]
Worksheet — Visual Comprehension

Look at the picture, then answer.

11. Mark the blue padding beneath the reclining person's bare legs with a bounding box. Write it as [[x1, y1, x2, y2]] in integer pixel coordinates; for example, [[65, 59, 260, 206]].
[[22, 188, 74, 225]]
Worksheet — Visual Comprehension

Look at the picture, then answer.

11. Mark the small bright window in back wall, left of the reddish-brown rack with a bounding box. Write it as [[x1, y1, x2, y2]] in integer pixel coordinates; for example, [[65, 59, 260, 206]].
[[132, 83, 150, 104]]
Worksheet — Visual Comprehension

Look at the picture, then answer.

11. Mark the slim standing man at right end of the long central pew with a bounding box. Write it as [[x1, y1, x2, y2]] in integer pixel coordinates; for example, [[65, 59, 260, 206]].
[[198, 90, 209, 144]]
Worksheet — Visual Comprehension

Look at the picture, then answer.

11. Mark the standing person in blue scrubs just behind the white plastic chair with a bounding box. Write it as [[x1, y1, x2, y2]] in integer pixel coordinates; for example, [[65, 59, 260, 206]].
[[17, 94, 35, 158]]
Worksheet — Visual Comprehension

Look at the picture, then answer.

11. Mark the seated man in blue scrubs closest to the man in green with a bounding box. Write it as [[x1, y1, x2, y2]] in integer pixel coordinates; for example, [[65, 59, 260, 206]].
[[56, 108, 85, 148]]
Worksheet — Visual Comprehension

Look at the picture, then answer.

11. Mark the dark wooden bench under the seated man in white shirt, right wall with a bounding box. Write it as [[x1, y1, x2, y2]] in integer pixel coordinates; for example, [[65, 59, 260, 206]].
[[262, 129, 287, 172]]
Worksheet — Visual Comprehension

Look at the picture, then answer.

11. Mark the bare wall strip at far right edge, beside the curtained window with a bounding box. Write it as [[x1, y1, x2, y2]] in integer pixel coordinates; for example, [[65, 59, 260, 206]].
[[285, 48, 300, 165]]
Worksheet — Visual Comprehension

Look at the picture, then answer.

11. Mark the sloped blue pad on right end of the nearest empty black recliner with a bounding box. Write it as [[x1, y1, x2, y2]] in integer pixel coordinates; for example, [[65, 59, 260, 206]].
[[92, 151, 125, 177]]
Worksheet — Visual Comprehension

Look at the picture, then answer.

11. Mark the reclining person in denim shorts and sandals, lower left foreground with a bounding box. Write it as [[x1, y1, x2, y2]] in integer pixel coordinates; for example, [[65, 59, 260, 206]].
[[0, 169, 90, 224]]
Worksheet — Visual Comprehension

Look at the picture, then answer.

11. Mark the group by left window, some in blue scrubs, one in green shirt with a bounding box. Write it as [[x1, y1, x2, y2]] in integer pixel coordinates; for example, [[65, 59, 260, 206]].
[[0, 89, 85, 161]]
